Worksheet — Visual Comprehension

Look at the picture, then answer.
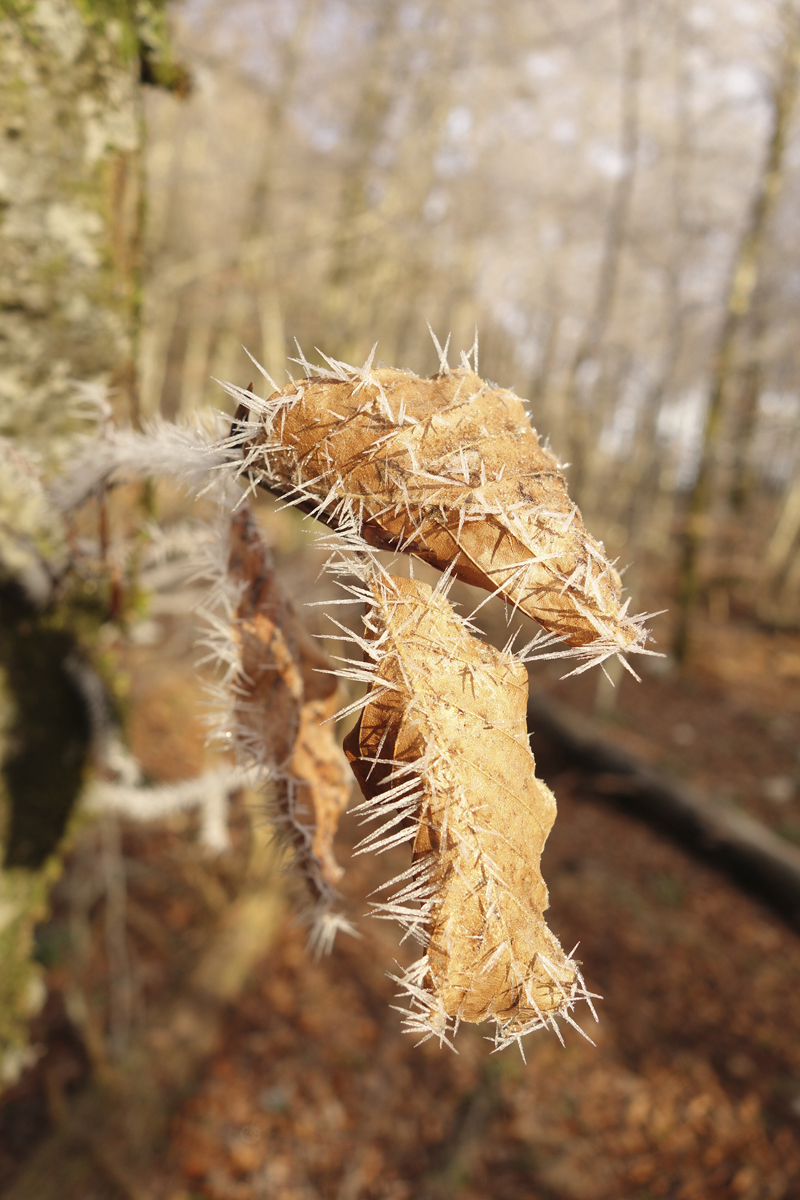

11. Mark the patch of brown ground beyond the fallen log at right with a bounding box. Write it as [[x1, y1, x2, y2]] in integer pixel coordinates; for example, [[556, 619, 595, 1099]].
[[535, 609, 800, 842]]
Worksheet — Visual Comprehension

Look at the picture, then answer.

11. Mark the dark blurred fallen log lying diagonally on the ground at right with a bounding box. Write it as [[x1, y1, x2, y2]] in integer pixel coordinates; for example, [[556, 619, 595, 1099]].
[[528, 691, 800, 929]]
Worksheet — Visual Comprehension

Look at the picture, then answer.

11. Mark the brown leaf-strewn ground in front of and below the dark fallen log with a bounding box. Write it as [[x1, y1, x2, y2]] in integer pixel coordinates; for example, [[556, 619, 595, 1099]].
[[154, 788, 800, 1200]]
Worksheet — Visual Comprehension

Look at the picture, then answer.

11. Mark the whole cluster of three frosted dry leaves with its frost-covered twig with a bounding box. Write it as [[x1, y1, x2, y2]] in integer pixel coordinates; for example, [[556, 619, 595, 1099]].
[[54, 340, 652, 1045]]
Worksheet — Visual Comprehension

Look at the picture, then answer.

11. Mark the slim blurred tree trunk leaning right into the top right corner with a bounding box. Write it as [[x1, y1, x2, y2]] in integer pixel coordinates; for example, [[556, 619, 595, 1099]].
[[674, 0, 800, 661]]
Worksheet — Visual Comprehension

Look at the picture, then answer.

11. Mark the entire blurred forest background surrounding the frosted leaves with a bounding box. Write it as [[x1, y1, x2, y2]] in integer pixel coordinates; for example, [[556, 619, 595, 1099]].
[[0, 0, 800, 1200]]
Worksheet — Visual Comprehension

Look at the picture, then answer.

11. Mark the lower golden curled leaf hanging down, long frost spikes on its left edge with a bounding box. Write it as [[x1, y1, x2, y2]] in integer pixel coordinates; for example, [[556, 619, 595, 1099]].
[[344, 575, 588, 1045]]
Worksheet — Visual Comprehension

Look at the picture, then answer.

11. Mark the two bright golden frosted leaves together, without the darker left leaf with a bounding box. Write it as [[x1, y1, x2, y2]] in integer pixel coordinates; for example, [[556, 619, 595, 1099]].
[[215, 343, 651, 1045]]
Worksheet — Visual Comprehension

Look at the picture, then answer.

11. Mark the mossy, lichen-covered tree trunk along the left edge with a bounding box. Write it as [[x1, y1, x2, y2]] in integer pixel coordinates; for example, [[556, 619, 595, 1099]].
[[0, 0, 160, 1087]]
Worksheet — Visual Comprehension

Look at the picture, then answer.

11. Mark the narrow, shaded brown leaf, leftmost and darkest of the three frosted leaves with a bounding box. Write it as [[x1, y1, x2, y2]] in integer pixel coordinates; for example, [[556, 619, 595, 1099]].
[[228, 506, 350, 928]]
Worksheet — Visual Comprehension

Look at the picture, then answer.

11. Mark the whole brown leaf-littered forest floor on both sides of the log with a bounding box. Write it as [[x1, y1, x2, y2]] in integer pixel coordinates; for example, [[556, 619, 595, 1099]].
[[0, 523, 800, 1200]]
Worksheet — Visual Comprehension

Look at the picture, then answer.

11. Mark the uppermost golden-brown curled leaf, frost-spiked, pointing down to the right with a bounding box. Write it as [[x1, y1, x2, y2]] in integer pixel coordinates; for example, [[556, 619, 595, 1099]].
[[231, 360, 648, 661]]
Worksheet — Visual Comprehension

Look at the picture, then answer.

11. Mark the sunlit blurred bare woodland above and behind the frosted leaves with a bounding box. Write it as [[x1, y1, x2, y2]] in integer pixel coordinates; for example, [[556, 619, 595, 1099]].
[[140, 0, 800, 640]]
